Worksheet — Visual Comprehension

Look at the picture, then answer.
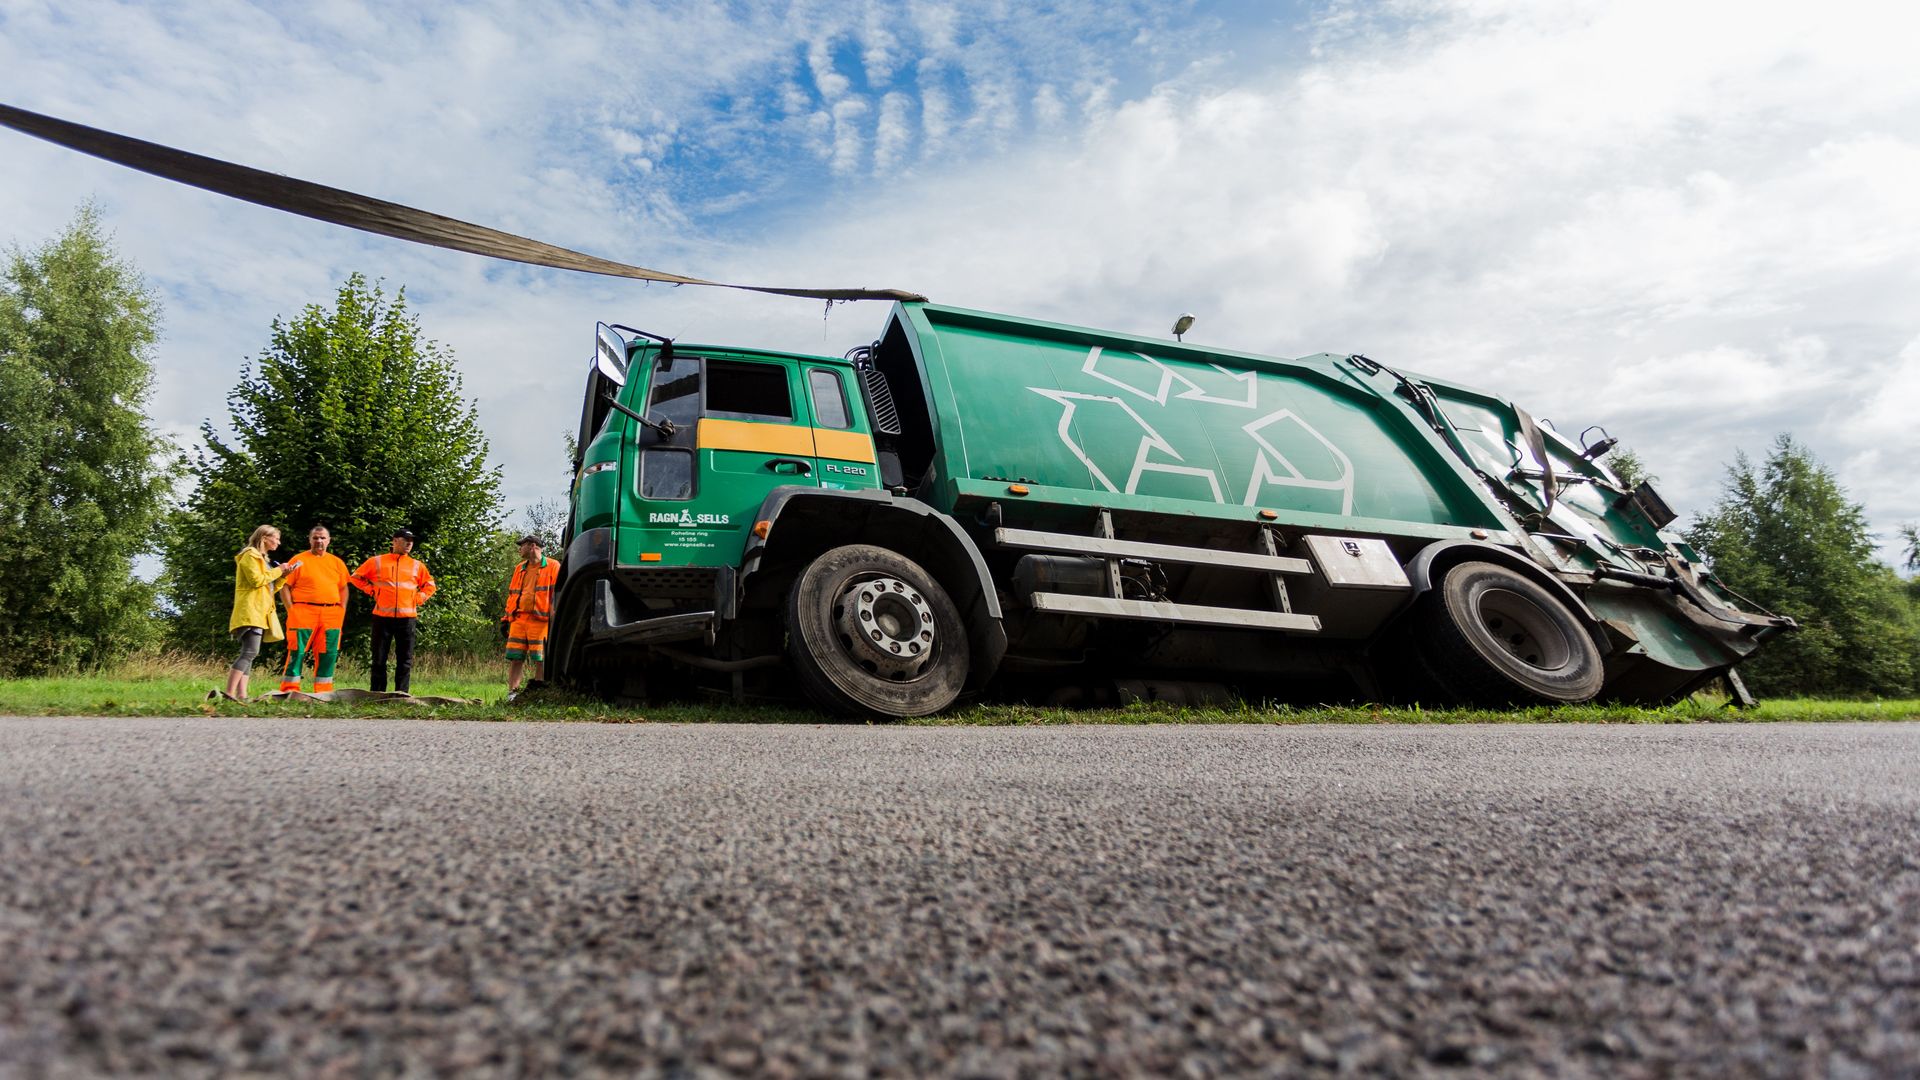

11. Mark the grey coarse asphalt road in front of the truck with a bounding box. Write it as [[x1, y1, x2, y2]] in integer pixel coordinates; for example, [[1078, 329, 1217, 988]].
[[0, 719, 1920, 1076]]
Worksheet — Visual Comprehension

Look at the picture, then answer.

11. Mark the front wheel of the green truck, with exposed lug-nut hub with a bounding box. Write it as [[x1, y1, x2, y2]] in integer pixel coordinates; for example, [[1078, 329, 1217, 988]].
[[787, 544, 970, 719]]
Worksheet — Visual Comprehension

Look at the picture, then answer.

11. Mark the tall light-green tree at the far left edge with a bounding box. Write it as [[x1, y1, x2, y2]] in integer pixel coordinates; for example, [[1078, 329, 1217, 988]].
[[0, 204, 177, 675]]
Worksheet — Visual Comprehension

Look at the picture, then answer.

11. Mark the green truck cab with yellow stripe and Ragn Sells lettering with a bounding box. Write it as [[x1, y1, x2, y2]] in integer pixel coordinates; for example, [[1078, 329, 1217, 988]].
[[549, 325, 952, 694]]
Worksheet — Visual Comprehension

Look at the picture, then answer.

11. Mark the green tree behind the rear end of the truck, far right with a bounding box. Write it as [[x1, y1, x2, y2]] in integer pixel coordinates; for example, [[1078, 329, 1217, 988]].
[[1688, 434, 1920, 696]]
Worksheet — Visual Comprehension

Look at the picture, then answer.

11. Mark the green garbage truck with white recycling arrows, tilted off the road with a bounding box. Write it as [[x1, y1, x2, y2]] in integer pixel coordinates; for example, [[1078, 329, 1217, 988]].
[[547, 302, 1793, 717]]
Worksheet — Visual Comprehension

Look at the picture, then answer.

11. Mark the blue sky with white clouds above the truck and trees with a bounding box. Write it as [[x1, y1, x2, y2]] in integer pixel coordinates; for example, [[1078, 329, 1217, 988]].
[[0, 0, 1920, 561]]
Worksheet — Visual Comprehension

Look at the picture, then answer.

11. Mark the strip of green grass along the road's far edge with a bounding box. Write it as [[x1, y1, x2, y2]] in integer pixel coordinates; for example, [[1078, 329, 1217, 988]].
[[0, 657, 1920, 726]]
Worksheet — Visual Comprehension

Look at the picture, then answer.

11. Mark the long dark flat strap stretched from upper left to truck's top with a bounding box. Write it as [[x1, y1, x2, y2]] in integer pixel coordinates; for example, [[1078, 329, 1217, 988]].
[[0, 106, 925, 300]]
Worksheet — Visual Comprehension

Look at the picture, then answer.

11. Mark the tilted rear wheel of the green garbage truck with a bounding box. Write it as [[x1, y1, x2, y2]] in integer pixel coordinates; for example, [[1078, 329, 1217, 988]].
[[1411, 561, 1605, 705]]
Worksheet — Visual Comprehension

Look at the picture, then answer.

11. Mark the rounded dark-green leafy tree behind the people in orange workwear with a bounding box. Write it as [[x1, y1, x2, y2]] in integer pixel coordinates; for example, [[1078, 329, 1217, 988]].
[[165, 275, 501, 650]]
